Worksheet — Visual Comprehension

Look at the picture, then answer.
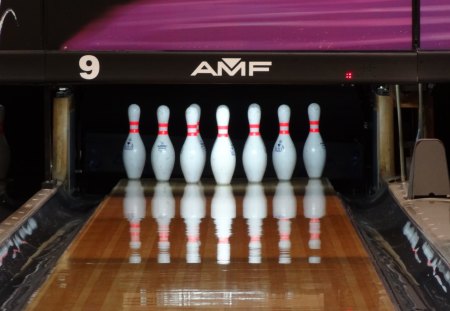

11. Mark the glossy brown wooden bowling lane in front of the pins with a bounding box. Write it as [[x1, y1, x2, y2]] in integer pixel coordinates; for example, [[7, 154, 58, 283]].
[[27, 180, 394, 310]]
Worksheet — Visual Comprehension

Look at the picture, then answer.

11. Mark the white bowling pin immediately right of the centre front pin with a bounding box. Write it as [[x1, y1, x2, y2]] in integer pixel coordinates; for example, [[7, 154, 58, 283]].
[[242, 104, 267, 182]]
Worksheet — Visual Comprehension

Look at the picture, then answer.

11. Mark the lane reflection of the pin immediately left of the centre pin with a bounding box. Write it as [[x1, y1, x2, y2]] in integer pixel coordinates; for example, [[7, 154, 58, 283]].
[[180, 184, 206, 263]]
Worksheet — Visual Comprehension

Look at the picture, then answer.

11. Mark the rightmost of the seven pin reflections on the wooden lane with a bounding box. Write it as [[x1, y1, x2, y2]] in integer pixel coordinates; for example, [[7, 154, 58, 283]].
[[303, 178, 326, 263]]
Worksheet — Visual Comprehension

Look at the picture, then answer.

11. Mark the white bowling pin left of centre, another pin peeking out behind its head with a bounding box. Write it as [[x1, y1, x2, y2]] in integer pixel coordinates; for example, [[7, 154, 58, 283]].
[[180, 105, 206, 183]]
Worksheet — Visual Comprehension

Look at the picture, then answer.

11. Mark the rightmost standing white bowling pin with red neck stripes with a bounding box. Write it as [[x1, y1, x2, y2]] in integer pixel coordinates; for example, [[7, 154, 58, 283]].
[[303, 103, 327, 178]]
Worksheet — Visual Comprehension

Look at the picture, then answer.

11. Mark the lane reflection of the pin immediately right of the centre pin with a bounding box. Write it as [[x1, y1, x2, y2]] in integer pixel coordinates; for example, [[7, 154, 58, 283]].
[[243, 183, 267, 263]]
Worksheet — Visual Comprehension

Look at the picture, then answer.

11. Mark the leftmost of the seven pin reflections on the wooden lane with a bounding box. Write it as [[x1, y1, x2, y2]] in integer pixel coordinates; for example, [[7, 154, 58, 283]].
[[123, 180, 145, 263]]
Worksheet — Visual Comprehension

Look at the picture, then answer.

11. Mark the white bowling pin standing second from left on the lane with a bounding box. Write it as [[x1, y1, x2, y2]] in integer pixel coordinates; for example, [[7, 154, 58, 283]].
[[151, 105, 175, 181]]
